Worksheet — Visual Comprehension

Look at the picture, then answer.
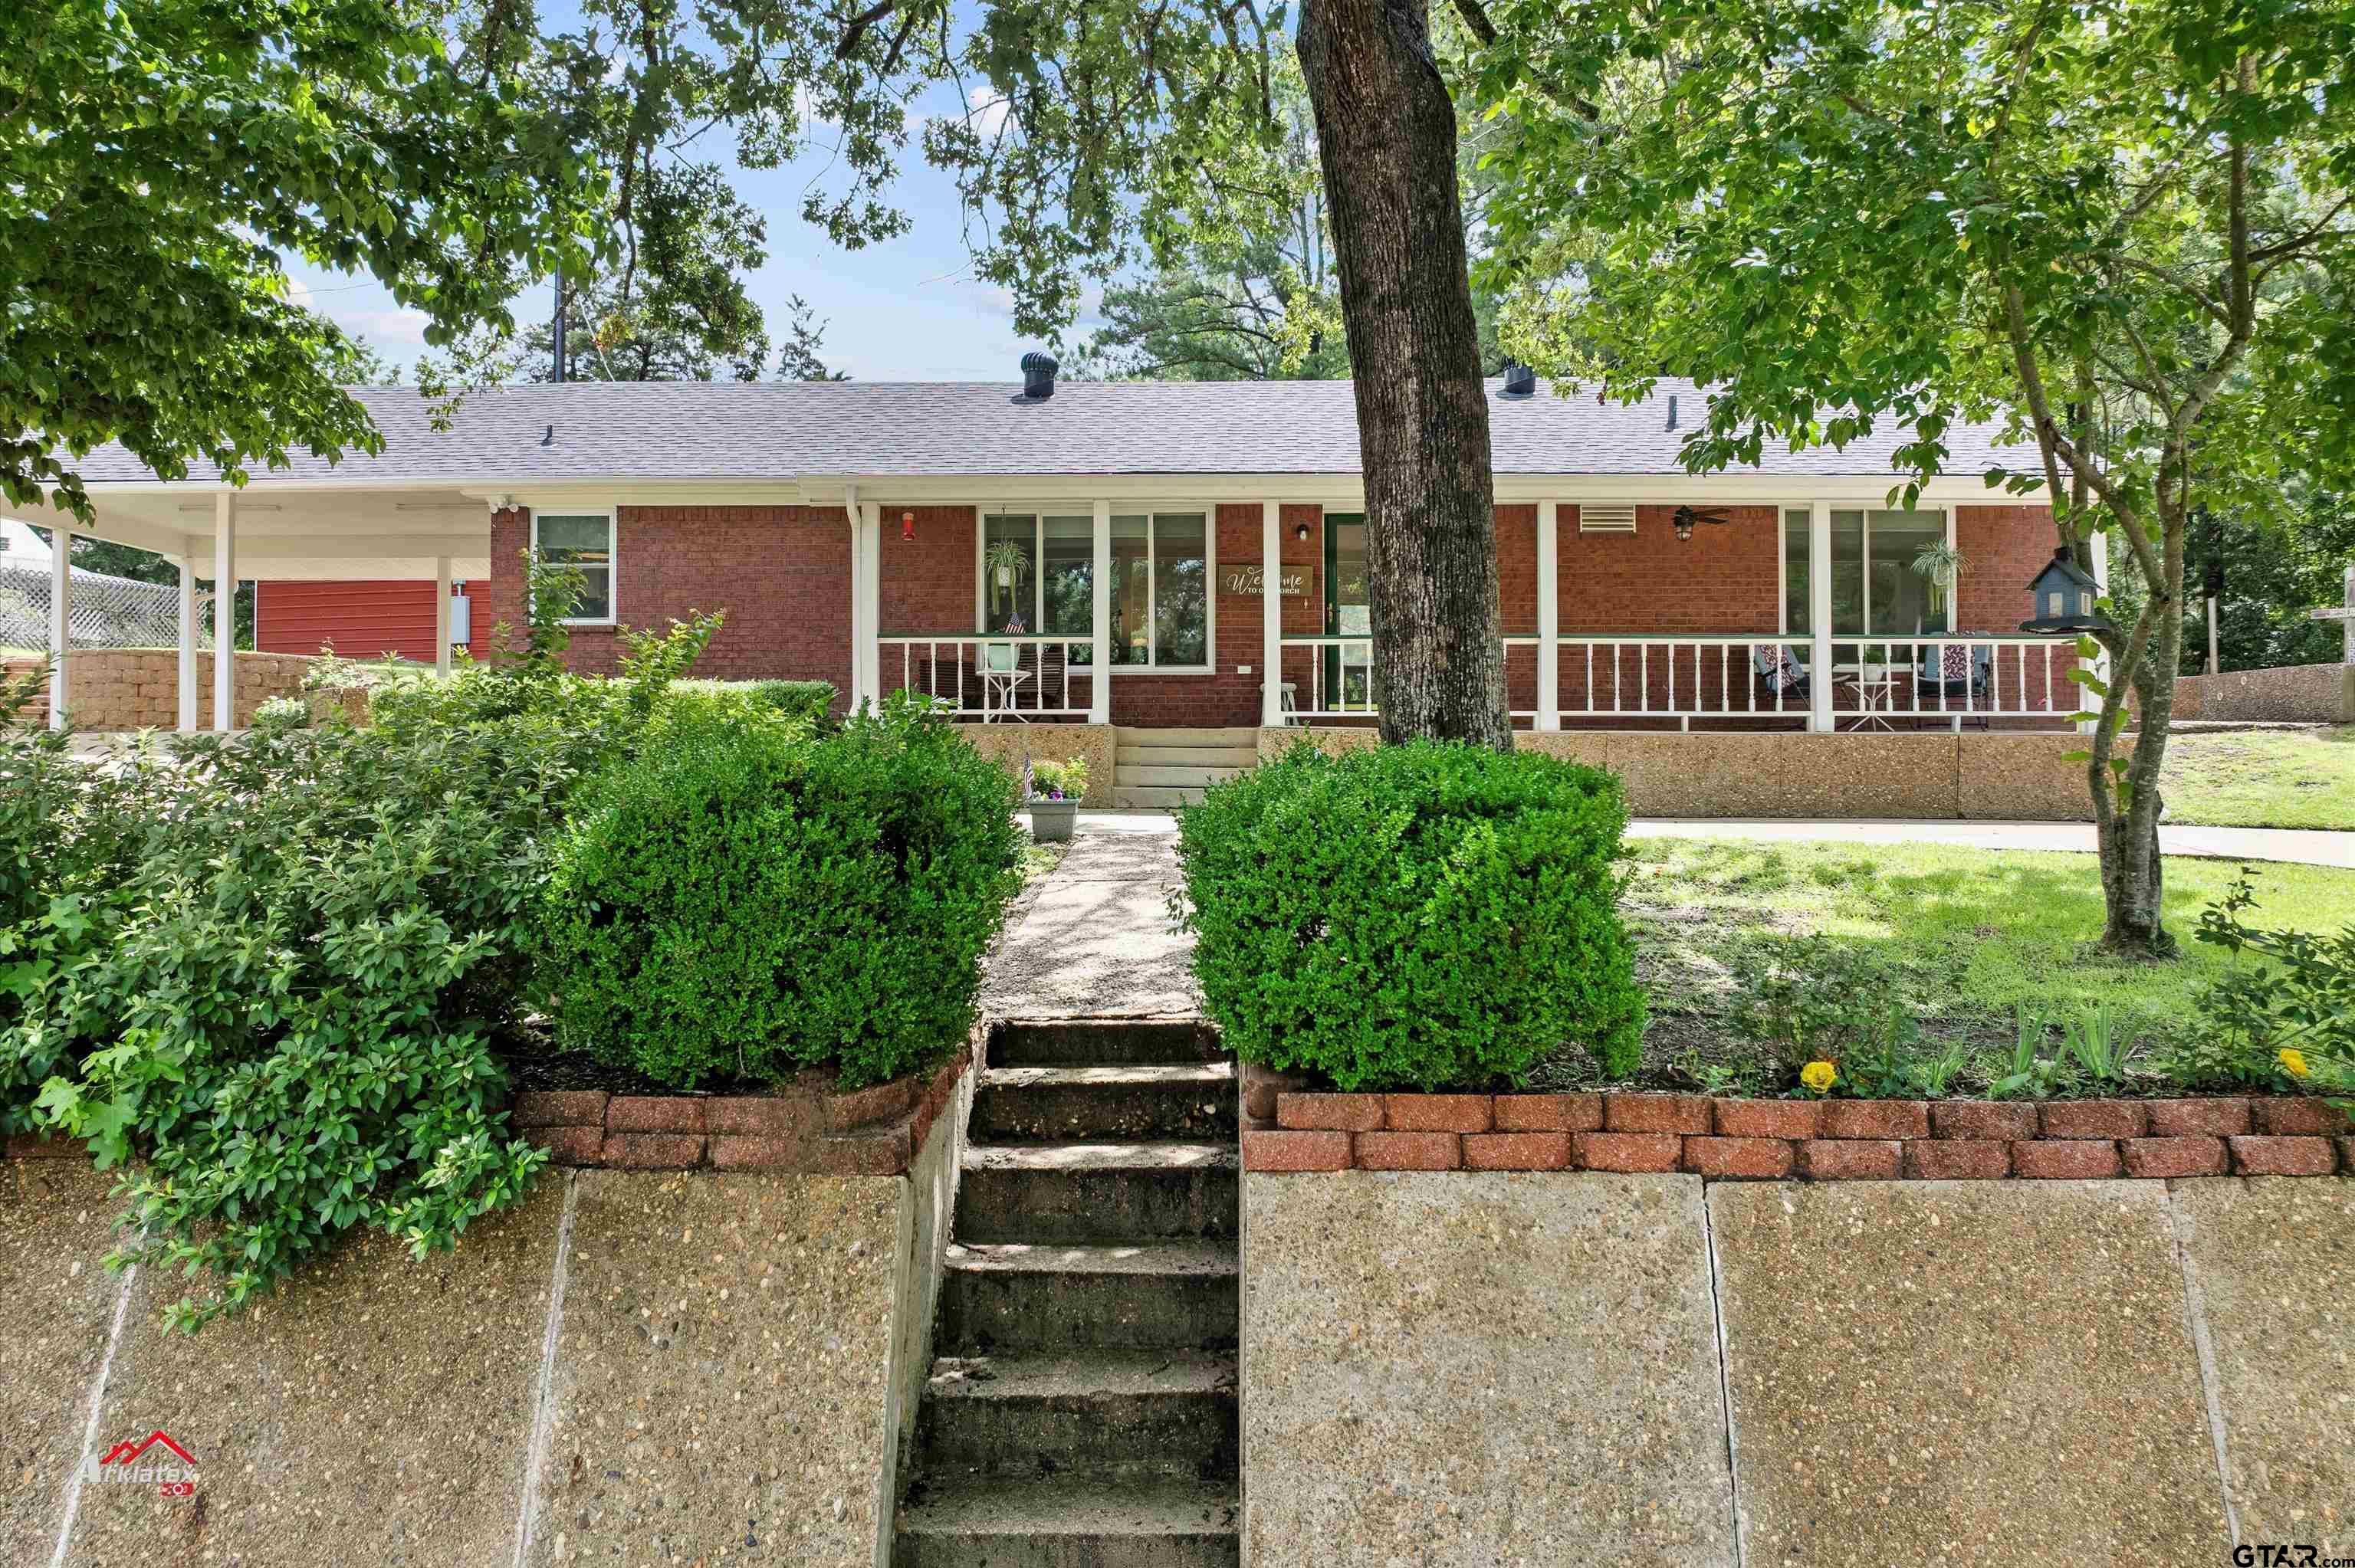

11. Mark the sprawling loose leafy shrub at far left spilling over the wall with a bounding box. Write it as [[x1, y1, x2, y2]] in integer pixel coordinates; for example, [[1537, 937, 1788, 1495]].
[[0, 602, 709, 1328]]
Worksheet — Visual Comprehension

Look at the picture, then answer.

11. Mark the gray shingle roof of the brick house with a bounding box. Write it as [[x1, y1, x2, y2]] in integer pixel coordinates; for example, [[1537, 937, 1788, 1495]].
[[83, 382, 2025, 483]]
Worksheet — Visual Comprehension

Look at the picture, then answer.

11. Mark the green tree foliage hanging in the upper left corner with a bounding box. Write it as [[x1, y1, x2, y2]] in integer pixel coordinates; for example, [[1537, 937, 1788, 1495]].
[[0, 0, 600, 523]]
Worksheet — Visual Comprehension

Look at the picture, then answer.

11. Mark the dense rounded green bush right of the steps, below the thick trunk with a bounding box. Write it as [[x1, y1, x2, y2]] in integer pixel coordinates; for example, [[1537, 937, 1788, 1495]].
[[1175, 742, 1644, 1090]]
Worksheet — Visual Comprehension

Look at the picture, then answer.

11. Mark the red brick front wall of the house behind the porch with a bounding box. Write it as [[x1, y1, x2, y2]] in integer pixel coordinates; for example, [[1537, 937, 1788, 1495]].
[[476, 501, 2074, 727]]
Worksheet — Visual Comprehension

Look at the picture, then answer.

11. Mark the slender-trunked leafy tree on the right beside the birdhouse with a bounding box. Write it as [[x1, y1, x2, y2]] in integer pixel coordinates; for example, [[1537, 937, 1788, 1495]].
[[1476, 0, 2355, 951]]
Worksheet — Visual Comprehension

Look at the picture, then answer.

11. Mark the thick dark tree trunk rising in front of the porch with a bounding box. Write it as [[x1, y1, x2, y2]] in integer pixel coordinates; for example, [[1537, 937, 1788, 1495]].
[[1300, 0, 1512, 751]]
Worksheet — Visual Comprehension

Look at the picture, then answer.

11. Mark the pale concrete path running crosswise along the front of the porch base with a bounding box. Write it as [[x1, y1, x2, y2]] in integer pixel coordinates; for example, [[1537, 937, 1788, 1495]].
[[1036, 812, 2355, 878]]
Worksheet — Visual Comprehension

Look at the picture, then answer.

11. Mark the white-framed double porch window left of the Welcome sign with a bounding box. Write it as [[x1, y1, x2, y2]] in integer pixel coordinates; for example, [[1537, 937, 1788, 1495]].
[[975, 506, 1217, 671]]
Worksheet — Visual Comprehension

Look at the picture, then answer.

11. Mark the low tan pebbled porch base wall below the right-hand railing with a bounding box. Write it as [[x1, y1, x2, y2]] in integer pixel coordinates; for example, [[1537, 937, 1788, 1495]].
[[1260, 725, 2094, 822]]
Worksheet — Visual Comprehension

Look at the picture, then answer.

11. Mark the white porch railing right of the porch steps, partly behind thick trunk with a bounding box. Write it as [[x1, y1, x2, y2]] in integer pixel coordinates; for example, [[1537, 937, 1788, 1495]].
[[1283, 631, 2077, 730]]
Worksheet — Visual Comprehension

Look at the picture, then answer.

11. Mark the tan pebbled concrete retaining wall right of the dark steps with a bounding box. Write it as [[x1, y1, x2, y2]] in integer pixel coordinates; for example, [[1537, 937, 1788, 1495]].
[[1243, 1170, 2355, 1568]]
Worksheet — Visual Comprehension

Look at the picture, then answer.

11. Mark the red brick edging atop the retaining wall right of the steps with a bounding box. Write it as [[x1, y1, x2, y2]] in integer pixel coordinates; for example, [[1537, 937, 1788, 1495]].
[[1243, 1087, 2355, 1182]]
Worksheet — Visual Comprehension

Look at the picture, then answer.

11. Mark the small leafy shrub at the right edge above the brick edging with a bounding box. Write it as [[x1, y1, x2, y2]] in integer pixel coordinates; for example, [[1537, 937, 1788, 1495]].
[[2157, 869, 2355, 1109]]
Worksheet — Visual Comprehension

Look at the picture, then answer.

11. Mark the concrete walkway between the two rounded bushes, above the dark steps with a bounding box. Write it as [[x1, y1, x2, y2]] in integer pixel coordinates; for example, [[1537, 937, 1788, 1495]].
[[982, 812, 1201, 1017]]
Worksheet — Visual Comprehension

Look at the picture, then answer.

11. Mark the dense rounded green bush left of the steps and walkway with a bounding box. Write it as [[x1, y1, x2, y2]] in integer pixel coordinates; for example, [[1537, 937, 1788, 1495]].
[[542, 704, 1020, 1087]]
